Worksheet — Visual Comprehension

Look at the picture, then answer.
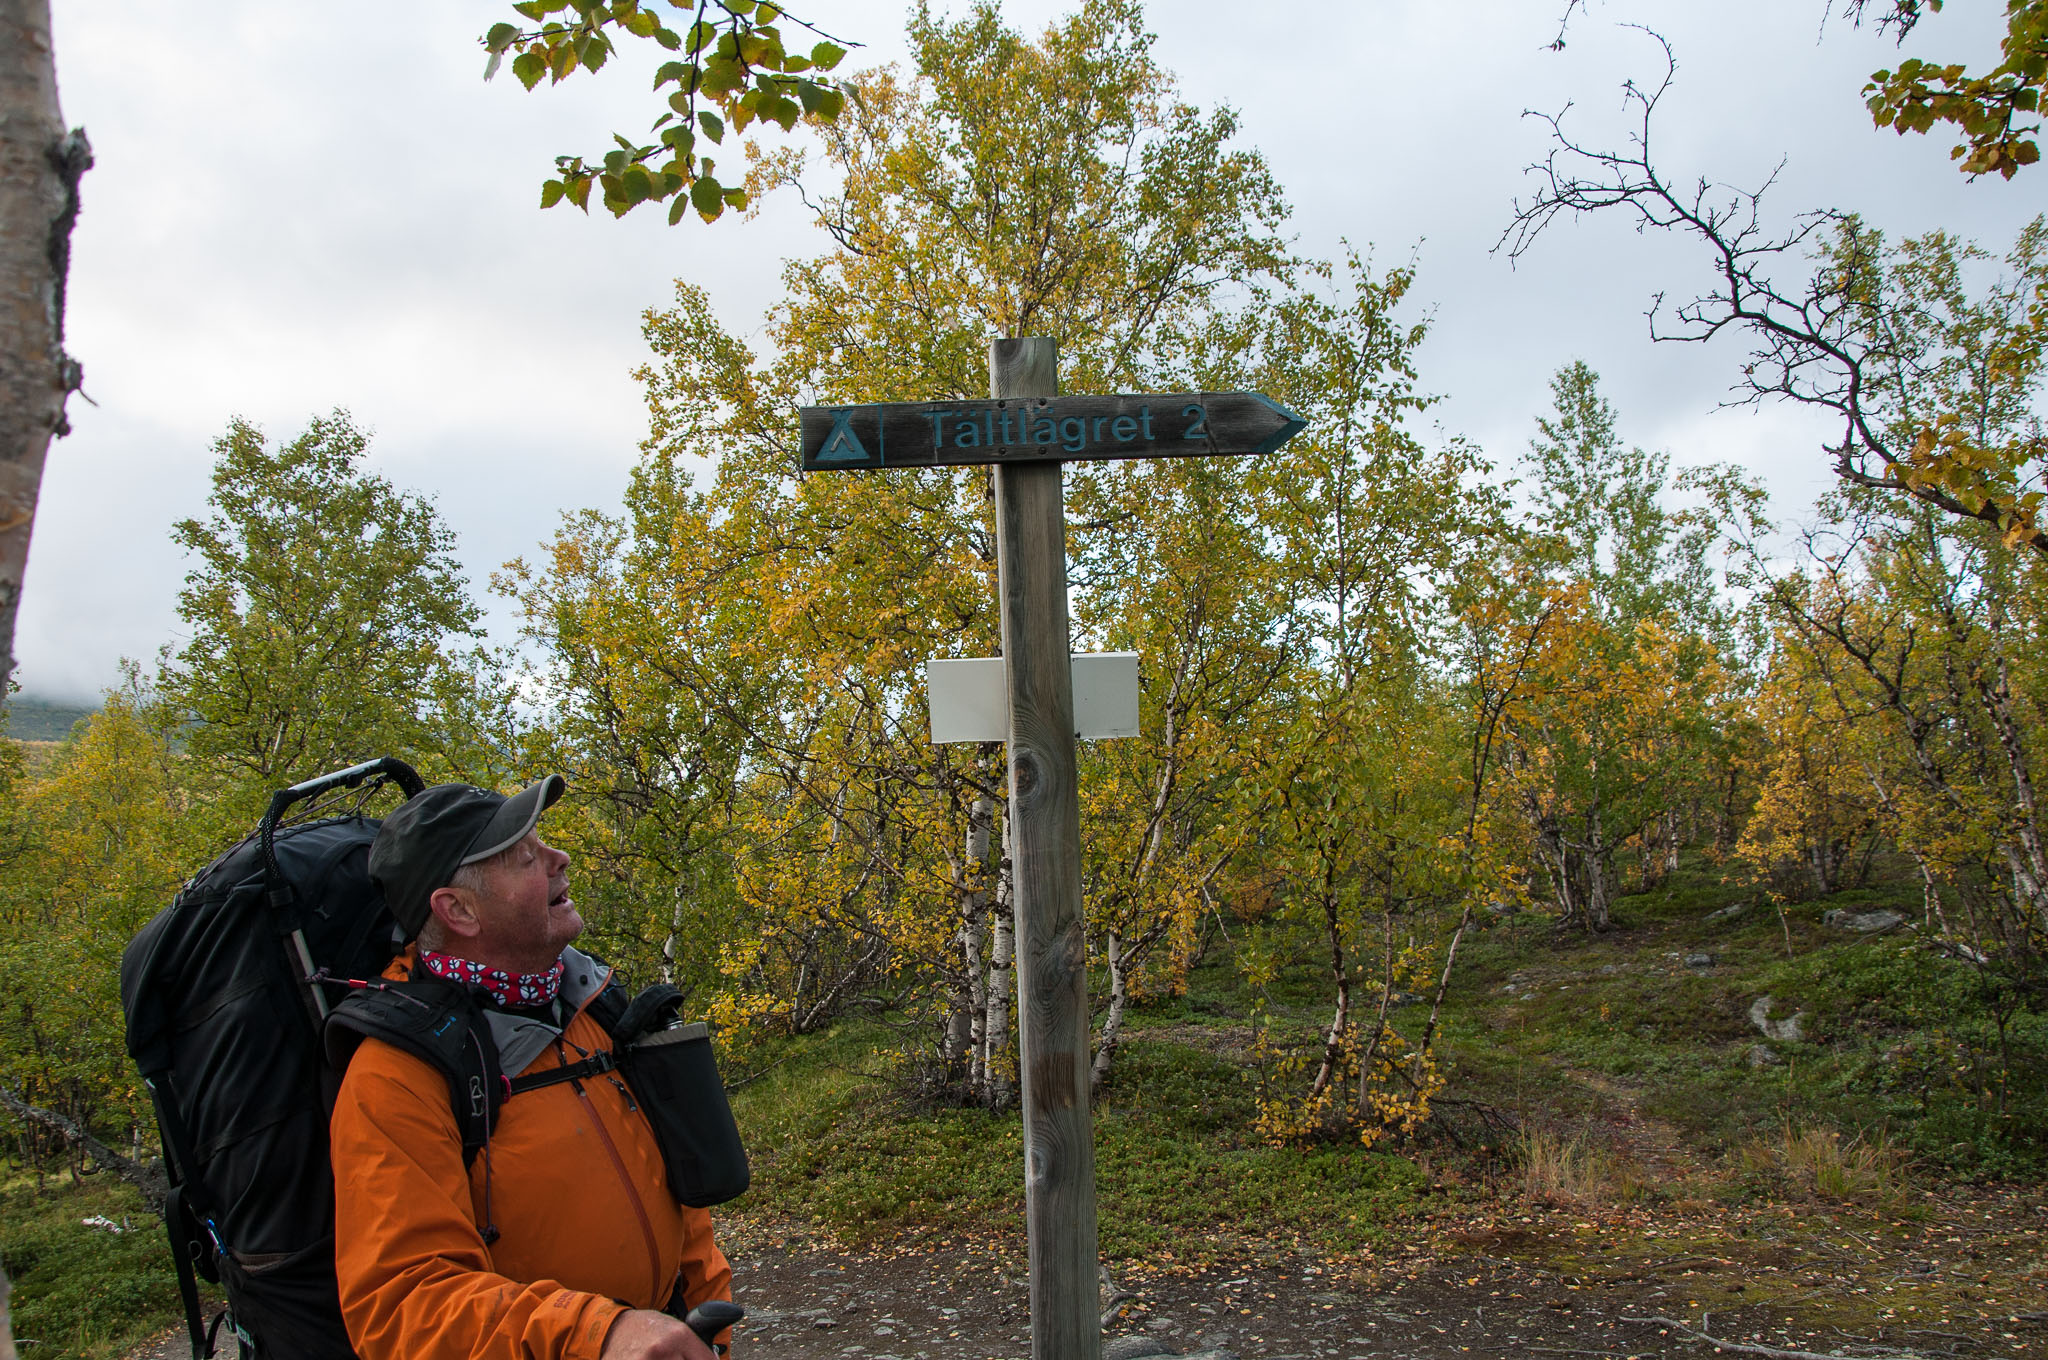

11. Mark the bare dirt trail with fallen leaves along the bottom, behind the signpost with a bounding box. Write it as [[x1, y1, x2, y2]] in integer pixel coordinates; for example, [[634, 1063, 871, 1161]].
[[129, 1202, 2048, 1360]]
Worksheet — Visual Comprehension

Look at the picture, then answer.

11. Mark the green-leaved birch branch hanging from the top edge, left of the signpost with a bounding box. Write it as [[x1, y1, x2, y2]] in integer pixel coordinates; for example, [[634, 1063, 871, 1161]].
[[483, 0, 850, 225]]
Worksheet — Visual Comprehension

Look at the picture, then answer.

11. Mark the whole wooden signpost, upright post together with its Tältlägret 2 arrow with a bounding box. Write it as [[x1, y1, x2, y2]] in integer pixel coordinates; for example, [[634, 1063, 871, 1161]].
[[801, 338, 1303, 1360]]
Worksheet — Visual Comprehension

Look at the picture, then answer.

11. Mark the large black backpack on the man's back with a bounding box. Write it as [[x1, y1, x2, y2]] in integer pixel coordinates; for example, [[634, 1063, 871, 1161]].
[[121, 758, 424, 1360]]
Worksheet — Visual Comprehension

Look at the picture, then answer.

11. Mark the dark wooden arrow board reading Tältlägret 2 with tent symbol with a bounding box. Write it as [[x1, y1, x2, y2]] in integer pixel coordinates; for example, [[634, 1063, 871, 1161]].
[[799, 391, 1305, 471]]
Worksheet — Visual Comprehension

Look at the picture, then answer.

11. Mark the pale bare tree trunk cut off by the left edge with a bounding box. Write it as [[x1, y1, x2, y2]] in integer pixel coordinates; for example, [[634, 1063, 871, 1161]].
[[0, 0, 92, 682]]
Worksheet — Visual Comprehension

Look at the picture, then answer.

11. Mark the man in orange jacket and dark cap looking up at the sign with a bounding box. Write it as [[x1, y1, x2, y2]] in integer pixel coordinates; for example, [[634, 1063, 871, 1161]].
[[330, 774, 731, 1360]]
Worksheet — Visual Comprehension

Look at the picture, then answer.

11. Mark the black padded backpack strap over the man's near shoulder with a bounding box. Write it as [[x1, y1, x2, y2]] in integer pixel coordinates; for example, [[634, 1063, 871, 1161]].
[[324, 977, 506, 1165]]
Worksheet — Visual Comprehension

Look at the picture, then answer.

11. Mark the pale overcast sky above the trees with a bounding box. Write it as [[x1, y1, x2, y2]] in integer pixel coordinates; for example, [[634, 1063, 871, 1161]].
[[16, 0, 2048, 700]]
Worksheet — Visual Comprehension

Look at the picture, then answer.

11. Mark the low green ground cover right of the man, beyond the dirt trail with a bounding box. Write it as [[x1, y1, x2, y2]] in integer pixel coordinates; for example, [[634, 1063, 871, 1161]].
[[735, 856, 2048, 1260]]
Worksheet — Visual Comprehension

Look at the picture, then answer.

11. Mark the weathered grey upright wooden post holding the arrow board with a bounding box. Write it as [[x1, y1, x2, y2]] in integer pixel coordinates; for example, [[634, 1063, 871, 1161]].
[[989, 338, 1102, 1360]]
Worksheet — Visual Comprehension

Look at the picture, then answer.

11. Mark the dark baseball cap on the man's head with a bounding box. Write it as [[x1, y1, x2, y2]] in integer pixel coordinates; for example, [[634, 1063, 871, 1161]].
[[371, 774, 569, 940]]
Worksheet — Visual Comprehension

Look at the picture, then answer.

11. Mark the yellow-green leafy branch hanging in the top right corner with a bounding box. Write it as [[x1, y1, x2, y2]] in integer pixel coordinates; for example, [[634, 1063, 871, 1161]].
[[1851, 0, 2048, 178]]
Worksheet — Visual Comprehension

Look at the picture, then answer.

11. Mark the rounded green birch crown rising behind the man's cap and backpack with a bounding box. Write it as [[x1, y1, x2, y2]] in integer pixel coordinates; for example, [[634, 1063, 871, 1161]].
[[158, 412, 499, 811]]
